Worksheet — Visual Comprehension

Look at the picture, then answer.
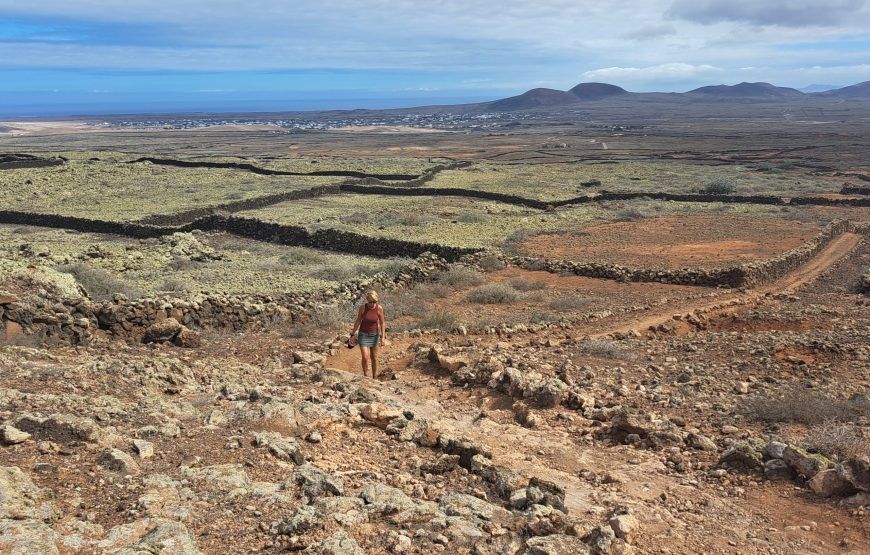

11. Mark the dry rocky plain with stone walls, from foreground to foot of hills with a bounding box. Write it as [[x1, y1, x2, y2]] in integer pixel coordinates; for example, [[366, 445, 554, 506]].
[[0, 111, 870, 555]]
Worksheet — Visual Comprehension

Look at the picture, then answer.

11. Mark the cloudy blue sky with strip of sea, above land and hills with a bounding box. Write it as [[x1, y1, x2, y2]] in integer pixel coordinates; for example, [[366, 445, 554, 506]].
[[0, 0, 870, 116]]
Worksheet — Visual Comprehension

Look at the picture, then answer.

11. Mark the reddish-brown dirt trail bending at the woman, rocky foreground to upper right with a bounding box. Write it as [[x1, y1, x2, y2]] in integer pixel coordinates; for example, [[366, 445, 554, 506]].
[[325, 229, 870, 553]]
